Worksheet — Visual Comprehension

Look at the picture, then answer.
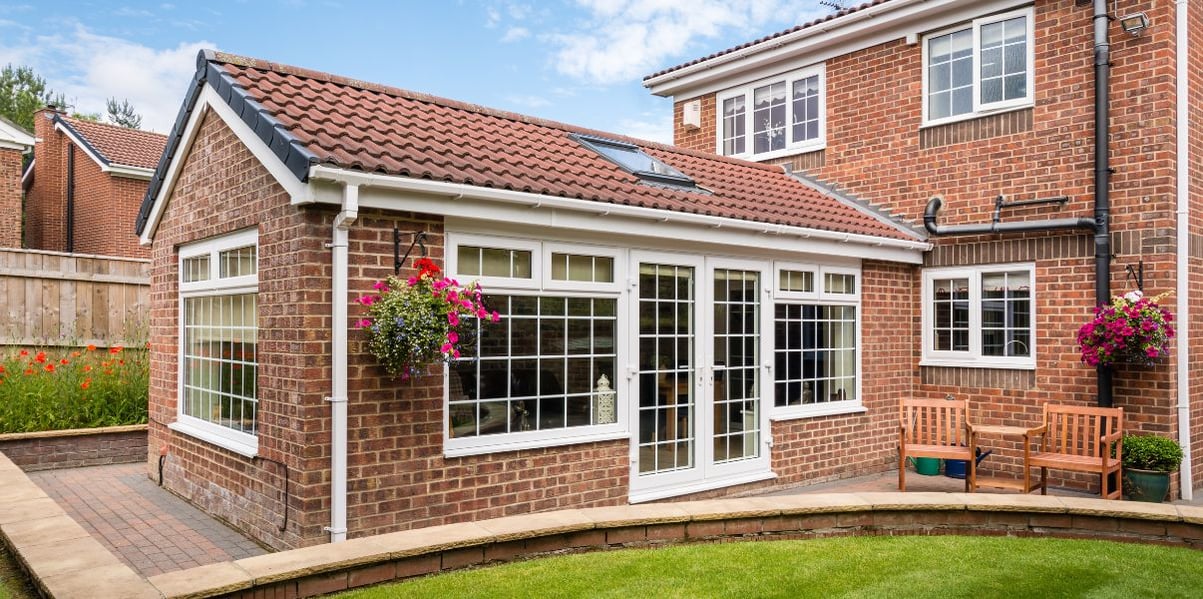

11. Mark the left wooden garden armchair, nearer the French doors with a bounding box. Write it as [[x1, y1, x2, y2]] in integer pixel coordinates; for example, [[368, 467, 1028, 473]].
[[899, 399, 977, 492]]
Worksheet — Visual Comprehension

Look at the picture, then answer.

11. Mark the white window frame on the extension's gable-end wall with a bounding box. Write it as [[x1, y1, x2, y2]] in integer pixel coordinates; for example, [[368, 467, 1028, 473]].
[[168, 229, 260, 457]]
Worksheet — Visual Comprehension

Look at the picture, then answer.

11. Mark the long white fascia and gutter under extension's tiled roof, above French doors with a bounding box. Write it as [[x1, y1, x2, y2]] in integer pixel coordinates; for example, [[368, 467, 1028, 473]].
[[309, 165, 931, 265]]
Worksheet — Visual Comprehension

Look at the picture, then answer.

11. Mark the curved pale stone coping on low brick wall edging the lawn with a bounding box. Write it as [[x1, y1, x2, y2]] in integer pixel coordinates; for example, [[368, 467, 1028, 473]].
[[149, 492, 1203, 598]]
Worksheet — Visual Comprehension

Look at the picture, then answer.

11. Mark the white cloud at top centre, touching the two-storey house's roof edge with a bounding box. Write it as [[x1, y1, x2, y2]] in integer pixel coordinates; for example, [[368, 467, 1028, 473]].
[[543, 0, 829, 84]]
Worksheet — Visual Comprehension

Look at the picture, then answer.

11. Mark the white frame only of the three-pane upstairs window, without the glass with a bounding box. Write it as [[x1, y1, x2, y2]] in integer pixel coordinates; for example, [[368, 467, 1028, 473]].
[[715, 63, 826, 160]]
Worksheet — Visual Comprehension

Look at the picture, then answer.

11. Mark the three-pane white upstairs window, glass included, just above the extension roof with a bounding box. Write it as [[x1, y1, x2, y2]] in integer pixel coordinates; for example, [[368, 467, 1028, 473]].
[[716, 65, 826, 160]]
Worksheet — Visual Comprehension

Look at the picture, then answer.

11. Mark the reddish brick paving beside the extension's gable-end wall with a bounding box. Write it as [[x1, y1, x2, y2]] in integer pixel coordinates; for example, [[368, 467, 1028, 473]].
[[28, 463, 267, 576]]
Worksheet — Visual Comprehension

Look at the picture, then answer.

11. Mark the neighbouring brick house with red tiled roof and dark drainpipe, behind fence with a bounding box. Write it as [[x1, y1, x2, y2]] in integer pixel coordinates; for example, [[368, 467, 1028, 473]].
[[24, 106, 167, 257]]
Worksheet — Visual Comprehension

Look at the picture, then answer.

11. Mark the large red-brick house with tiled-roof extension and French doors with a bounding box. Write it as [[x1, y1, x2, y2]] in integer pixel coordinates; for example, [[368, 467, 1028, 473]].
[[137, 0, 1203, 547]]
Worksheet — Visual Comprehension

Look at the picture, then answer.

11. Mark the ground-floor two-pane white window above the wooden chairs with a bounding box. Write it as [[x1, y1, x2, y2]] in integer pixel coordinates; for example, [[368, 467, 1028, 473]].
[[923, 263, 1036, 369]]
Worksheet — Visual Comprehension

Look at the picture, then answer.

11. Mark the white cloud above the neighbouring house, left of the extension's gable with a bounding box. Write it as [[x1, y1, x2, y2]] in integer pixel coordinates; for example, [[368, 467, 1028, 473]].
[[0, 25, 215, 134]]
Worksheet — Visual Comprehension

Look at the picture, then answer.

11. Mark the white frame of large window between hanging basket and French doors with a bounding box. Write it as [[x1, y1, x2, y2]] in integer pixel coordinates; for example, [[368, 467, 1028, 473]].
[[443, 231, 632, 457]]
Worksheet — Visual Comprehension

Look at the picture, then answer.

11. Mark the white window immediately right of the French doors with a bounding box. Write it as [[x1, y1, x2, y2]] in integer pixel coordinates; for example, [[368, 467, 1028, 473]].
[[772, 262, 864, 420]]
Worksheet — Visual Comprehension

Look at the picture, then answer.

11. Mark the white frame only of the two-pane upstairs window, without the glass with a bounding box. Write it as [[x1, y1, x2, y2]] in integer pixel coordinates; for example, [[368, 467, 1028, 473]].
[[920, 6, 1036, 127]]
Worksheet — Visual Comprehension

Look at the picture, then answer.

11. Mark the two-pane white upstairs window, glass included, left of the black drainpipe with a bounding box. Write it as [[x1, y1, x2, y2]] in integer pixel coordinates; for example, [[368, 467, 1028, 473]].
[[923, 8, 1035, 125]]
